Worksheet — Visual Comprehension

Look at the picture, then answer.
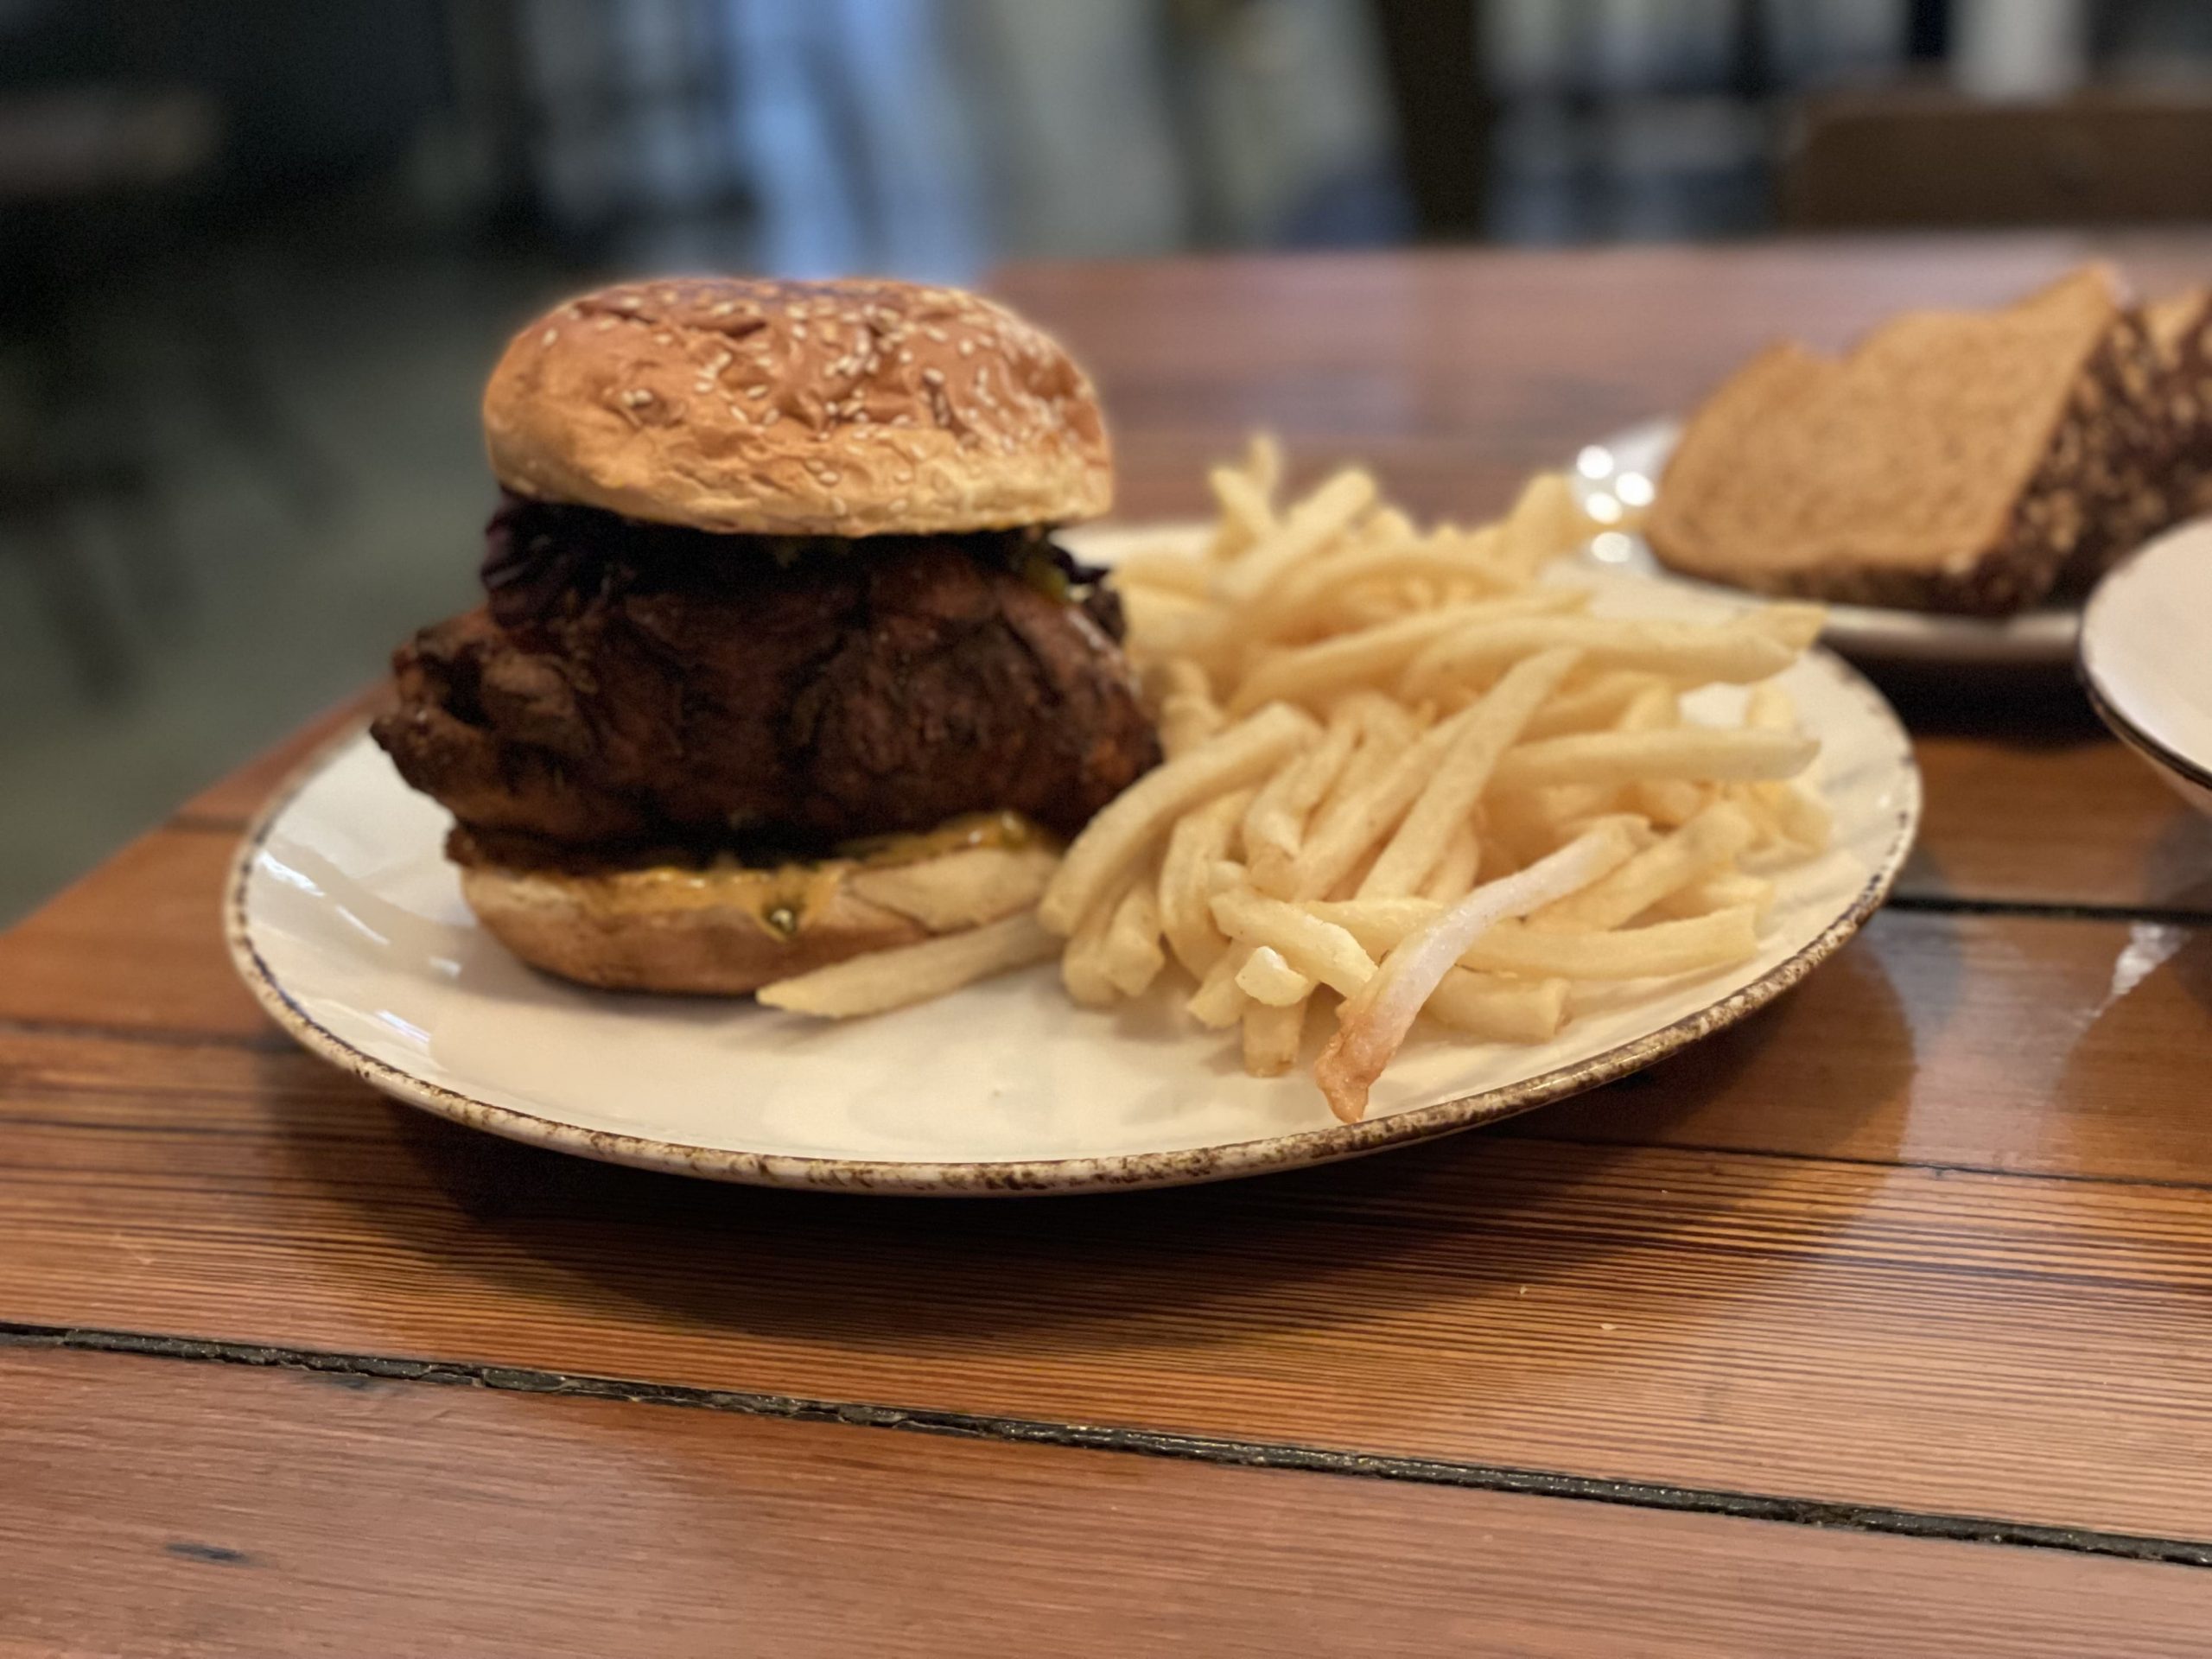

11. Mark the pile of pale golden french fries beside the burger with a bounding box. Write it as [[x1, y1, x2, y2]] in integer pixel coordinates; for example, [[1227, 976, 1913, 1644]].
[[763, 438, 1829, 1122]]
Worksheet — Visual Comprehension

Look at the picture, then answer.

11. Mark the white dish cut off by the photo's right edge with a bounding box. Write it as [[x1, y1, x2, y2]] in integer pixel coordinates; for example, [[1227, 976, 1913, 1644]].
[[2082, 520, 2212, 814]]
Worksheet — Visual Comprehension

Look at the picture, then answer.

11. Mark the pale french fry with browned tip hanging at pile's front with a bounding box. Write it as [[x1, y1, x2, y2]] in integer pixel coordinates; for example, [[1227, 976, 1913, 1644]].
[[1314, 825, 1645, 1123]]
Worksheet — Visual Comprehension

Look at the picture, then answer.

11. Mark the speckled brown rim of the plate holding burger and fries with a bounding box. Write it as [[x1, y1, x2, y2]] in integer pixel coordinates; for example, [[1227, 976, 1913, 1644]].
[[224, 651, 1920, 1197]]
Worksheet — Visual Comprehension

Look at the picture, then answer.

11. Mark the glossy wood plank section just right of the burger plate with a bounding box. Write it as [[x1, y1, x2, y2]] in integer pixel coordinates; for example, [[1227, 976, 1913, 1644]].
[[1504, 912, 2212, 1185]]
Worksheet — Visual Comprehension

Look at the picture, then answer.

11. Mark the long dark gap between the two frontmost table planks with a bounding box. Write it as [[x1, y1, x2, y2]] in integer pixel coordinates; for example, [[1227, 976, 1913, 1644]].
[[0, 1320, 2212, 1566]]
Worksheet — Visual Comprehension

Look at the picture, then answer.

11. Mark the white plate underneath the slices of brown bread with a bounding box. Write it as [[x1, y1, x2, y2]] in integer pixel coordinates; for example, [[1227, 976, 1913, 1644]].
[[1573, 420, 2082, 668]]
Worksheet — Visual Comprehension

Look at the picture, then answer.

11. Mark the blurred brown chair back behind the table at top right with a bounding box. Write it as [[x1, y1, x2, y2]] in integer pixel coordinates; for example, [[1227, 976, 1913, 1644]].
[[1778, 88, 2212, 230]]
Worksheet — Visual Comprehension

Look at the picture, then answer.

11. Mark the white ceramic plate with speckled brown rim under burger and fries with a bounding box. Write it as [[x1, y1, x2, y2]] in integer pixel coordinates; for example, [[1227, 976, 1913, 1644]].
[[228, 570, 1920, 1192]]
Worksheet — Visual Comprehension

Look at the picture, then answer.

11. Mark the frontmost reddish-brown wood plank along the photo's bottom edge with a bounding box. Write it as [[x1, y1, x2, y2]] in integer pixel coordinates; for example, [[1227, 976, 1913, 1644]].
[[0, 1350, 2212, 1659]]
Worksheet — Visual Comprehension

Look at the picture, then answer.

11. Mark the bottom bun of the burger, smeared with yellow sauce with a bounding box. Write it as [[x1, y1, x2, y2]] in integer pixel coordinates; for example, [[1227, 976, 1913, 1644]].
[[460, 847, 1055, 995]]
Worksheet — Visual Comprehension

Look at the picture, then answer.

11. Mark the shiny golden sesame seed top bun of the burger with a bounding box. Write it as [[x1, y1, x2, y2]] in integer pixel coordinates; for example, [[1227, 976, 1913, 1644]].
[[485, 276, 1113, 536]]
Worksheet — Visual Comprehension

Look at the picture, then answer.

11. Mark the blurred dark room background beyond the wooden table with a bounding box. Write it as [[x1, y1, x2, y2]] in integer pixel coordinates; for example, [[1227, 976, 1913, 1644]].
[[0, 0, 2212, 925]]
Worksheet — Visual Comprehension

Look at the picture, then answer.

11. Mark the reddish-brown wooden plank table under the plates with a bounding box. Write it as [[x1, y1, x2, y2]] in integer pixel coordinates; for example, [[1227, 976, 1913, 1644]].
[[0, 238, 2212, 1655]]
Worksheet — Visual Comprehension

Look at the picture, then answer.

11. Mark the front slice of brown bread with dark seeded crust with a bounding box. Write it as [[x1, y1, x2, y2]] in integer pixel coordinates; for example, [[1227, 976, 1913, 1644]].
[[1646, 265, 2170, 615]]
